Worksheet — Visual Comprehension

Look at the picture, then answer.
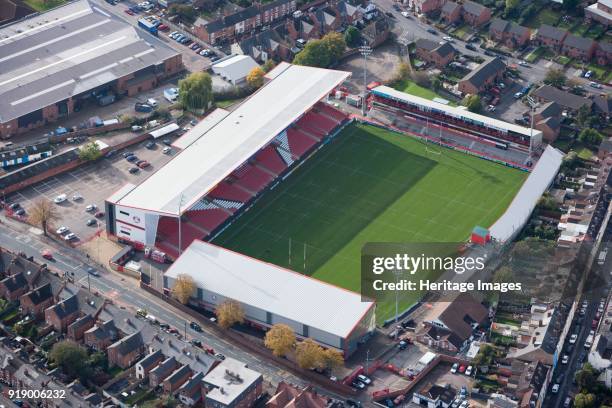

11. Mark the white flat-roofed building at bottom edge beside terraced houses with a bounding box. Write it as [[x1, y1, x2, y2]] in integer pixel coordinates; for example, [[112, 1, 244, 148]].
[[204, 357, 263, 408]]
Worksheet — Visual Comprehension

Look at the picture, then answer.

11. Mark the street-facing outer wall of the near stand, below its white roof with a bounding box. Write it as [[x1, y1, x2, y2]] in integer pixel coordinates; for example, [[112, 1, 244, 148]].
[[164, 276, 376, 356]]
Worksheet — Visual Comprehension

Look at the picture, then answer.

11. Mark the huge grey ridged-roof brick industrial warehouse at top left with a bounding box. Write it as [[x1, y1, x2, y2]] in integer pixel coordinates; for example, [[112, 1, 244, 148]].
[[0, 0, 183, 138]]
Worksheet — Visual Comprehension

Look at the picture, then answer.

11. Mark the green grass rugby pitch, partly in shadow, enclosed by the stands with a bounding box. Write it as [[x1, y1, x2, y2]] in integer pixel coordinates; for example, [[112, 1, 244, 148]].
[[214, 124, 527, 322]]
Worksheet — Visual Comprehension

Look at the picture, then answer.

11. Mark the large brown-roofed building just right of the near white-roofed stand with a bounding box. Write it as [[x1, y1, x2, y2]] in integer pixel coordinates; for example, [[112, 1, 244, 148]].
[[417, 293, 489, 349]]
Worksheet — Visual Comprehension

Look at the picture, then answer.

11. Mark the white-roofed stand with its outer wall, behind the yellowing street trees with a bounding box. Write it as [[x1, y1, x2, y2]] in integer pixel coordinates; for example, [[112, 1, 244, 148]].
[[164, 240, 375, 354]]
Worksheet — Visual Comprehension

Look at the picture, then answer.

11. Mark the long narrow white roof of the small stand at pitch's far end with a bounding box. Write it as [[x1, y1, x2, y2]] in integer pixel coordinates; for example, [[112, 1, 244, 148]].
[[372, 85, 542, 140]]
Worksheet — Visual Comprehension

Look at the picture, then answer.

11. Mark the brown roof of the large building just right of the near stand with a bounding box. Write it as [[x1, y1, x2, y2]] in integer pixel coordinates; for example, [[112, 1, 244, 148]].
[[438, 293, 489, 342]]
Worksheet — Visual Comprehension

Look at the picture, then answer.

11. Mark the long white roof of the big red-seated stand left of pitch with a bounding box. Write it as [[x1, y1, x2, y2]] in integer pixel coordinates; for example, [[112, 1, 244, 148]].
[[112, 64, 350, 215]]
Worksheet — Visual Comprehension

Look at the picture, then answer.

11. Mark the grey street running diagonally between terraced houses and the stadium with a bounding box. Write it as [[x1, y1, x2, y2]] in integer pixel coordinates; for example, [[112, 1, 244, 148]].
[[0, 217, 339, 398]]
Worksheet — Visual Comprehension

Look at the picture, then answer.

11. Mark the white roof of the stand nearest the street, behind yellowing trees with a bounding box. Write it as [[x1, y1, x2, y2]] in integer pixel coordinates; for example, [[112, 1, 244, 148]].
[[165, 240, 374, 338]]
